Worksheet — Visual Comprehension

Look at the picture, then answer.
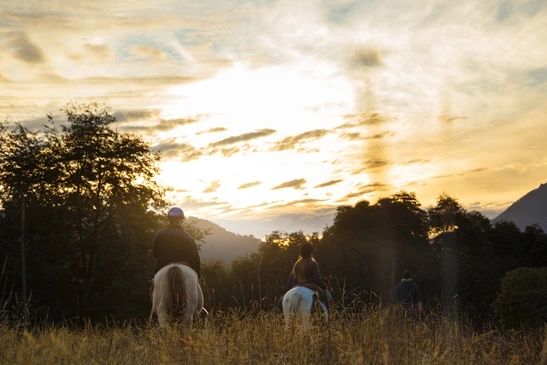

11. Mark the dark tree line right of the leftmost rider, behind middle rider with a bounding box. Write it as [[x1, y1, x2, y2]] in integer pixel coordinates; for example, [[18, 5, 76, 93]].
[[225, 192, 547, 324]]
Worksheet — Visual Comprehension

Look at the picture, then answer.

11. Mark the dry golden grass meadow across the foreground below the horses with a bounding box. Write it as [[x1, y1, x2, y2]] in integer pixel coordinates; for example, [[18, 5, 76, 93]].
[[0, 308, 547, 365]]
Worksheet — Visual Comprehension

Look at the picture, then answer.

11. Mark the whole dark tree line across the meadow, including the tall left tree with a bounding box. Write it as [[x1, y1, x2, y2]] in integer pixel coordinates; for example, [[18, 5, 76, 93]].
[[0, 103, 547, 323]]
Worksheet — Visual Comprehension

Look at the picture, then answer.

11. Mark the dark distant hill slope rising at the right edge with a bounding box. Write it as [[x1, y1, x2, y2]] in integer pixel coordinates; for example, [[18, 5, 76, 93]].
[[492, 183, 547, 231]]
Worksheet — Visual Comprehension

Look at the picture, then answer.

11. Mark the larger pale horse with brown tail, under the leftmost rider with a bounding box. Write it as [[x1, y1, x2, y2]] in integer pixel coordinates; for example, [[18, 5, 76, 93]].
[[149, 263, 204, 330]]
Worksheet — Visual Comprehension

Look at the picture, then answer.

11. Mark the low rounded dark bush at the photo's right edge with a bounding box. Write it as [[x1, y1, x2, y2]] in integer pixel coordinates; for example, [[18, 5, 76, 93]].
[[493, 267, 547, 328]]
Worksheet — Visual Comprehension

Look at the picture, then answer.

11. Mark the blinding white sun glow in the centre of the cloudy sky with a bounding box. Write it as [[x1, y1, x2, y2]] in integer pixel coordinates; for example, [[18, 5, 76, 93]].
[[158, 61, 360, 214]]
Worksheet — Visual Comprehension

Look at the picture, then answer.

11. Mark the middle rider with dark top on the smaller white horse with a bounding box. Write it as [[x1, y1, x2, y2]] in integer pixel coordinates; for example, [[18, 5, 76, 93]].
[[287, 243, 330, 308]]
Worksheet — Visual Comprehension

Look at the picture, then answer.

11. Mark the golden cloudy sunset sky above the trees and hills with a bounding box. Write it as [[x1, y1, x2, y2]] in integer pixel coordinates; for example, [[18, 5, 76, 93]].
[[0, 0, 547, 238]]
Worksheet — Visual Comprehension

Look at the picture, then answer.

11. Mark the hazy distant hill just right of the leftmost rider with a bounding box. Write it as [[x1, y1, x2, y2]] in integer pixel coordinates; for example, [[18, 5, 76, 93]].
[[189, 217, 260, 264]]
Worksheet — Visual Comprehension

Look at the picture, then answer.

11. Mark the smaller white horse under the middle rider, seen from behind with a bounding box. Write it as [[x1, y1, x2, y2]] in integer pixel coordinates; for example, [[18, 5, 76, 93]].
[[282, 286, 332, 331]]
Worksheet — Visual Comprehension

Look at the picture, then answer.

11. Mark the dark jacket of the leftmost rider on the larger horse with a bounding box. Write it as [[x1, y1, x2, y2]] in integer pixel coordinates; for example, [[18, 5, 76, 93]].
[[152, 225, 201, 277]]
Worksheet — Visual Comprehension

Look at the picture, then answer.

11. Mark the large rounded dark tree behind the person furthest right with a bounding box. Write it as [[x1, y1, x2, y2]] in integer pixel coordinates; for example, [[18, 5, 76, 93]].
[[317, 192, 433, 302]]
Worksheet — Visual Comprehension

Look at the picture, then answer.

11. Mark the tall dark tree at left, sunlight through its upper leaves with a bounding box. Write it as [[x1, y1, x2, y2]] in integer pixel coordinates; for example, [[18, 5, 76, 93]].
[[0, 103, 165, 316]]
